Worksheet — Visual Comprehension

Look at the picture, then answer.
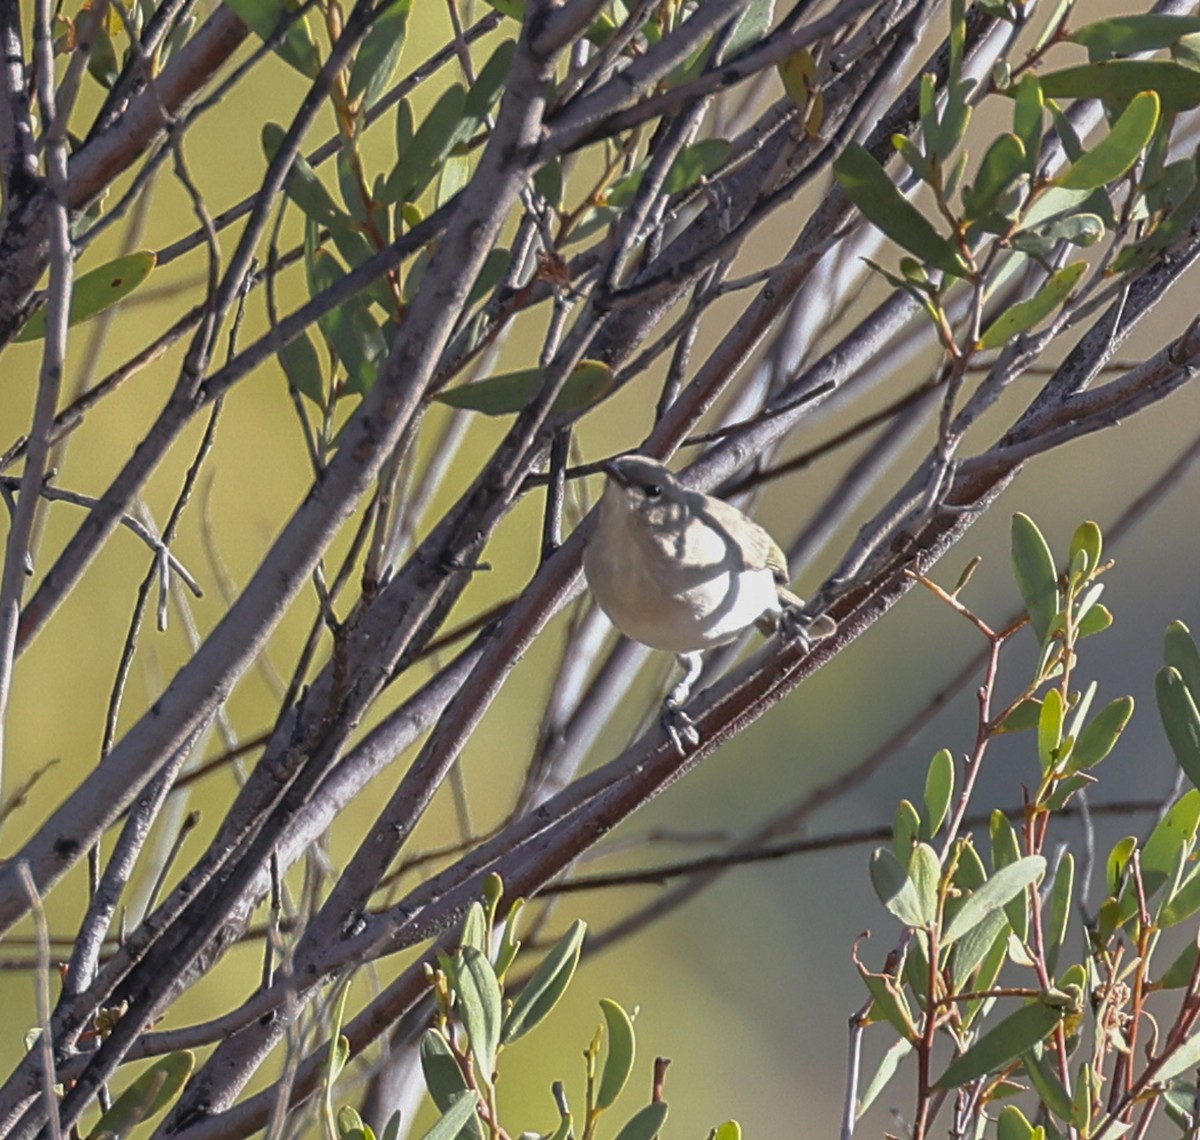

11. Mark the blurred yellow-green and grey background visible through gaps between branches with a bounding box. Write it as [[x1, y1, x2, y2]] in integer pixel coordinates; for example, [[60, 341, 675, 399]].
[[0, 4, 1200, 1138]]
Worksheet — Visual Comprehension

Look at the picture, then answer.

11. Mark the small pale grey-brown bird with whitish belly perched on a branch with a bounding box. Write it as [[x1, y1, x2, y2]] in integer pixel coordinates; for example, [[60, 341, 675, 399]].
[[583, 455, 838, 755]]
